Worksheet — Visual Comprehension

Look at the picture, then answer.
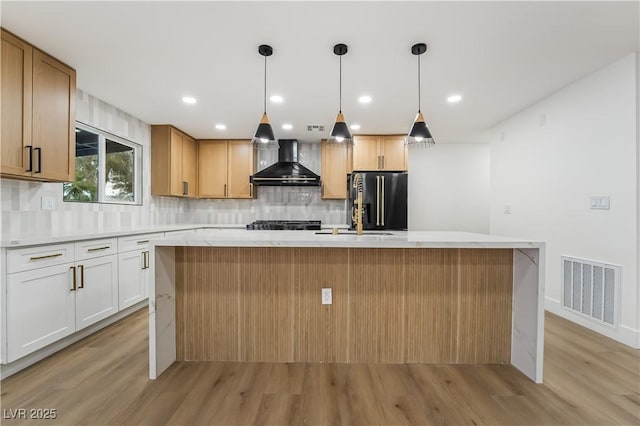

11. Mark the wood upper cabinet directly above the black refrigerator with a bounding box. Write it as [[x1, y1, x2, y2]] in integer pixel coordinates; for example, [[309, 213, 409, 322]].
[[352, 135, 407, 171]]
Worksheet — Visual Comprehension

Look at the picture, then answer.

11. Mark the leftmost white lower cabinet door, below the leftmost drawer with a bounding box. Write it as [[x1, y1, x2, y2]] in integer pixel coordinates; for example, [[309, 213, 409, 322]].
[[7, 263, 76, 362]]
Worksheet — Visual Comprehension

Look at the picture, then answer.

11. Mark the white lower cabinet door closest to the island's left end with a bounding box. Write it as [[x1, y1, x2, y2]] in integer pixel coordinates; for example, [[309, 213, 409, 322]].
[[118, 250, 149, 309]]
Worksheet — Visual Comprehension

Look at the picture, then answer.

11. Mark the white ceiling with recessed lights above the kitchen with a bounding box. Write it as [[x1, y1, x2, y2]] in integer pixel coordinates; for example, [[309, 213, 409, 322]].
[[1, 1, 639, 142]]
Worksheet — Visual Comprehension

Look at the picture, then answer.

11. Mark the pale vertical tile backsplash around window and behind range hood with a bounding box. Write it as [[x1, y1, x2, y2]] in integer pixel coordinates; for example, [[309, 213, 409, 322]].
[[0, 90, 346, 239]]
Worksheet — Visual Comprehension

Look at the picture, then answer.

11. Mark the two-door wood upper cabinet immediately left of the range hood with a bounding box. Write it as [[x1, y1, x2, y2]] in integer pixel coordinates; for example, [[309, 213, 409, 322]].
[[198, 139, 254, 198]]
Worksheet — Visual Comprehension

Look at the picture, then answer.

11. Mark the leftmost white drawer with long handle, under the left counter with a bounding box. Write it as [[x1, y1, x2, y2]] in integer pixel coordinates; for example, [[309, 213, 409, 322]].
[[7, 243, 74, 274]]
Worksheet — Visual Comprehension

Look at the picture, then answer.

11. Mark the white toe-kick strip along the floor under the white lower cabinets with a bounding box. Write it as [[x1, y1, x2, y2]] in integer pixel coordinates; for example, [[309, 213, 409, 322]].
[[0, 299, 149, 380]]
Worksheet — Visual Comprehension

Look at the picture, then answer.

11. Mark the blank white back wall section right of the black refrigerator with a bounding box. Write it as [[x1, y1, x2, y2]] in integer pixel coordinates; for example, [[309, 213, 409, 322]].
[[408, 143, 489, 233]]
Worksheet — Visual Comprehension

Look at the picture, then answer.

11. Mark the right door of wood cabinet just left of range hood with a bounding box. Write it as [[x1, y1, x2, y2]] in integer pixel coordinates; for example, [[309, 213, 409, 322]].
[[227, 140, 254, 198]]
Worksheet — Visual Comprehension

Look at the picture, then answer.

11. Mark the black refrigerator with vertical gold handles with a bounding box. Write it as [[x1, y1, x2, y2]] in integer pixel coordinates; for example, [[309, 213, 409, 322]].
[[347, 171, 407, 230]]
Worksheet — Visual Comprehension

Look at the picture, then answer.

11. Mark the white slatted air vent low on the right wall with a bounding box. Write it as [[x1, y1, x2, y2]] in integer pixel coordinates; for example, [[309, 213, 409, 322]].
[[561, 256, 620, 326]]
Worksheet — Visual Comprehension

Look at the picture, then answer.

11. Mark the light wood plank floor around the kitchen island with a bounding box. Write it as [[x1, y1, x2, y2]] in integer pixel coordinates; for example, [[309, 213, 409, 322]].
[[1, 310, 640, 425]]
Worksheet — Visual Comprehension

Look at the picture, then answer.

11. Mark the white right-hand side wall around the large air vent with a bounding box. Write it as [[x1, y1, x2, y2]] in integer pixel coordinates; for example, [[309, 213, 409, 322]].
[[489, 54, 640, 347]]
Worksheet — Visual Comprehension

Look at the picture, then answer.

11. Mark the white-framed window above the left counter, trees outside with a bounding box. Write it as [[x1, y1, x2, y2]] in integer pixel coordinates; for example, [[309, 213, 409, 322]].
[[63, 123, 142, 204]]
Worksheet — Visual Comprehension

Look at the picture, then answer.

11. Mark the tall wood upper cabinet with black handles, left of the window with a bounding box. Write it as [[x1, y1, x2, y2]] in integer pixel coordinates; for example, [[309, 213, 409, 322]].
[[0, 30, 76, 182]]
